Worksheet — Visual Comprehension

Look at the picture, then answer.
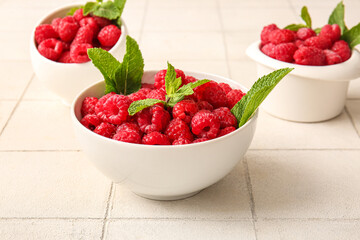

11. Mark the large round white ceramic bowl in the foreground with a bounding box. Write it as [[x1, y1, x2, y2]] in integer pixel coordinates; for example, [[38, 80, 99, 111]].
[[71, 71, 258, 200]]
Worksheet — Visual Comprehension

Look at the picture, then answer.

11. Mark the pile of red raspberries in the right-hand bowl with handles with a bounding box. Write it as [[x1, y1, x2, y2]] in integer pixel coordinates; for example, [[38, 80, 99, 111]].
[[260, 24, 351, 66]]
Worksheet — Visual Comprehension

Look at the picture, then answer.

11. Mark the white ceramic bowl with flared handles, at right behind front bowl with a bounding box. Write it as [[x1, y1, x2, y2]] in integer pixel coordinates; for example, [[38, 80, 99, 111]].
[[246, 41, 360, 122]]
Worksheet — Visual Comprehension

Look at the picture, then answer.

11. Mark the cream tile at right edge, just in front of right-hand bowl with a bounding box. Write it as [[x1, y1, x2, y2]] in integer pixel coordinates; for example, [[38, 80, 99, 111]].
[[250, 109, 360, 149]]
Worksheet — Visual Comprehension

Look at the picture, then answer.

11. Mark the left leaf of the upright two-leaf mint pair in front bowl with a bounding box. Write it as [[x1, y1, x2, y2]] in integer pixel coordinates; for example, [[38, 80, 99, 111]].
[[87, 48, 121, 94]]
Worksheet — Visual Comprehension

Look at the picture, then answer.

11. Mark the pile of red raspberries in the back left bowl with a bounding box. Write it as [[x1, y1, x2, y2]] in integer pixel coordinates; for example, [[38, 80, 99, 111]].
[[35, 9, 121, 63]]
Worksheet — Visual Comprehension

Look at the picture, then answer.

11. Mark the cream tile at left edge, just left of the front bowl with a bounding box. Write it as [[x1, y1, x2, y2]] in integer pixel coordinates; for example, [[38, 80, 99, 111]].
[[0, 101, 80, 150]]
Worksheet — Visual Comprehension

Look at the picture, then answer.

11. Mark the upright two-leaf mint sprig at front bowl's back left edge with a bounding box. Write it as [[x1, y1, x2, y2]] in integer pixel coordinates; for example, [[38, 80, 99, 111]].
[[88, 36, 144, 95]]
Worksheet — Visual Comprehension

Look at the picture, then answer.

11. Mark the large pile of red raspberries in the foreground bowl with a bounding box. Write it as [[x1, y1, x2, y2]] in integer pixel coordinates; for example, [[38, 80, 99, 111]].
[[80, 69, 245, 145]]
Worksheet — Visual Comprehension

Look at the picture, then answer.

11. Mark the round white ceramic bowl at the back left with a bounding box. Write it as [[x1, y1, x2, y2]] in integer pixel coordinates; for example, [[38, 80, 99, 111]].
[[30, 4, 128, 105]]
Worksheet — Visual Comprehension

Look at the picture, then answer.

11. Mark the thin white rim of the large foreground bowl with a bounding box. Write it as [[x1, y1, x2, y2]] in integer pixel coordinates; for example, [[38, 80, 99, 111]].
[[70, 69, 259, 149]]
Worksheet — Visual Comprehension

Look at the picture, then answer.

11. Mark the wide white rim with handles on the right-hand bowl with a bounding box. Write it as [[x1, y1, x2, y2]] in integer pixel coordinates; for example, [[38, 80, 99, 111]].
[[246, 40, 360, 82]]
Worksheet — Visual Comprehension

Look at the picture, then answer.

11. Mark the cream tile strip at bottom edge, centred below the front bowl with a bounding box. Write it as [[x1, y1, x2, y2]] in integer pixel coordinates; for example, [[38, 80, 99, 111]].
[[106, 219, 255, 240]]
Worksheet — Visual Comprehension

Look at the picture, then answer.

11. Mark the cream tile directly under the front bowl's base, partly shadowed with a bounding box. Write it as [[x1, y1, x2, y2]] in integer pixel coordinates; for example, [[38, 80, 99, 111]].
[[110, 163, 251, 220]]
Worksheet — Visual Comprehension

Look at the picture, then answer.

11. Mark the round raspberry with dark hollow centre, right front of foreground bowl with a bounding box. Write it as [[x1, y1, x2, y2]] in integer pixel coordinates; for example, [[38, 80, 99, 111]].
[[191, 110, 220, 139]]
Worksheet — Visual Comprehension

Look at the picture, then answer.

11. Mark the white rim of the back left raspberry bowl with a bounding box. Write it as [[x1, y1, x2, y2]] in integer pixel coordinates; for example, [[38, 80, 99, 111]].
[[30, 2, 128, 67]]
